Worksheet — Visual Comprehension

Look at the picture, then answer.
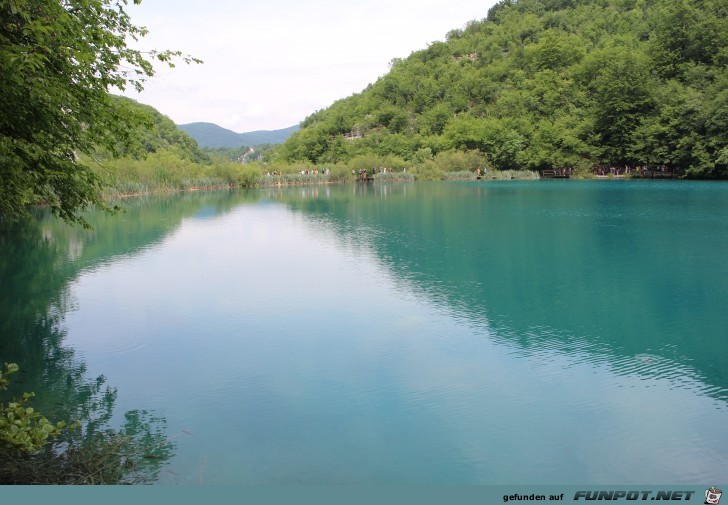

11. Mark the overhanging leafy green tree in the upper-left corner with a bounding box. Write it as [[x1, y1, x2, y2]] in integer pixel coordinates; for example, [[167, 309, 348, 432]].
[[0, 0, 200, 226]]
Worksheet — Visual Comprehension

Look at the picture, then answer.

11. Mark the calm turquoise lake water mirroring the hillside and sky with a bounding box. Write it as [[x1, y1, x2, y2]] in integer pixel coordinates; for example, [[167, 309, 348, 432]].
[[0, 181, 728, 485]]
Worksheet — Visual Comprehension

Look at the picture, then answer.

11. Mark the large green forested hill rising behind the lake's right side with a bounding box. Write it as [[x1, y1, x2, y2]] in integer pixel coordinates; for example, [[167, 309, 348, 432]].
[[277, 0, 728, 177]]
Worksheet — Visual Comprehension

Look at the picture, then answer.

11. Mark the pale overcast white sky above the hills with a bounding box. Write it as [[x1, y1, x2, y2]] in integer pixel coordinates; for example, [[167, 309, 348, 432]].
[[123, 0, 495, 133]]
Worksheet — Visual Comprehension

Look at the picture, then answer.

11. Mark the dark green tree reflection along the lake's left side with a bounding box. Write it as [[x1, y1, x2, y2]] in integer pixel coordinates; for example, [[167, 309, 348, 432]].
[[0, 195, 250, 483]]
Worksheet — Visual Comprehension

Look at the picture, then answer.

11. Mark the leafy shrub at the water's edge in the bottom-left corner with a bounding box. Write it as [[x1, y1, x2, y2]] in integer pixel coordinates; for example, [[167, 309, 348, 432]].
[[0, 363, 174, 484]]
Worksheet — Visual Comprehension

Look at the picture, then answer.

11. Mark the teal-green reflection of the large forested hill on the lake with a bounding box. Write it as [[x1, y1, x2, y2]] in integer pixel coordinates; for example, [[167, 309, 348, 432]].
[[278, 182, 728, 400]]
